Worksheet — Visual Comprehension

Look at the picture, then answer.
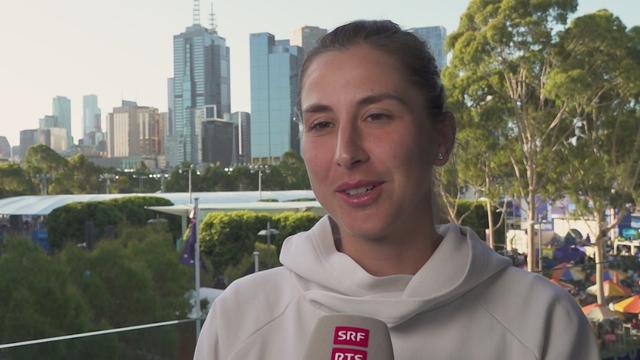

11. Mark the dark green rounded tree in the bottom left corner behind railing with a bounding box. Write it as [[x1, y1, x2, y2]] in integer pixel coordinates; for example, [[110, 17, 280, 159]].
[[0, 238, 109, 359]]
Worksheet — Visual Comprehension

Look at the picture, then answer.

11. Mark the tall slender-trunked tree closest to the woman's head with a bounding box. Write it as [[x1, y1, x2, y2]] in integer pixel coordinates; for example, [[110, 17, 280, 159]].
[[445, 0, 578, 270]]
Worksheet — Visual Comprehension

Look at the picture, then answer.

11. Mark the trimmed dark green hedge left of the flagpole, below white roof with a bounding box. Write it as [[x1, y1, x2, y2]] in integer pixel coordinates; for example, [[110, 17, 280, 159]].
[[47, 196, 180, 251]]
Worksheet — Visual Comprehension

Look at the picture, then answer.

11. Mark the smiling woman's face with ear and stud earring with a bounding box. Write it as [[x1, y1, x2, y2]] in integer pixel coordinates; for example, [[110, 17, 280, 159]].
[[301, 45, 447, 239]]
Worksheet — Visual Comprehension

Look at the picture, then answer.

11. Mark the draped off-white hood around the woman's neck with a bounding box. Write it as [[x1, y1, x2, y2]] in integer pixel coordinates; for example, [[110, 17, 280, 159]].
[[280, 216, 511, 327]]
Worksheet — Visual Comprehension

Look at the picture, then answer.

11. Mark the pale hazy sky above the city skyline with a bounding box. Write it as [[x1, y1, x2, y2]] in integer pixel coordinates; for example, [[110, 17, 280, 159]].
[[0, 0, 640, 146]]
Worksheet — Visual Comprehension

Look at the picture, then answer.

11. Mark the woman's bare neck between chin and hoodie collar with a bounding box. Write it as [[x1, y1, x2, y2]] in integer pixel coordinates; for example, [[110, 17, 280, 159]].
[[331, 219, 442, 276]]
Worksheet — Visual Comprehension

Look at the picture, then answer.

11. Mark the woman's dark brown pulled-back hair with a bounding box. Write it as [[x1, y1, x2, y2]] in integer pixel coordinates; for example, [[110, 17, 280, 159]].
[[298, 20, 445, 118]]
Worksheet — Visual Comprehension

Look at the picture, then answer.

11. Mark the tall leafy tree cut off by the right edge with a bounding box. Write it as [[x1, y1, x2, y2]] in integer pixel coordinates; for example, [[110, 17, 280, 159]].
[[545, 10, 640, 304]]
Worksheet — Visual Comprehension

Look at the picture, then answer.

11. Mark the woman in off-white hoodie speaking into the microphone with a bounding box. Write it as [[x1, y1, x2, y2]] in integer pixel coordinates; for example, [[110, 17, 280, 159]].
[[195, 21, 597, 360]]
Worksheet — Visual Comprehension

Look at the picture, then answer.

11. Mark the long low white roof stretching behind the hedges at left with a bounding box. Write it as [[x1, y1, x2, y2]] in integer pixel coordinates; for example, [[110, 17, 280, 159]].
[[0, 190, 319, 216]]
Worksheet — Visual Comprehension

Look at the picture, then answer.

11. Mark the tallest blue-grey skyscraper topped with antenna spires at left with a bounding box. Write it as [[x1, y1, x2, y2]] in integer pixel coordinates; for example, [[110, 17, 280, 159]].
[[167, 5, 231, 166]]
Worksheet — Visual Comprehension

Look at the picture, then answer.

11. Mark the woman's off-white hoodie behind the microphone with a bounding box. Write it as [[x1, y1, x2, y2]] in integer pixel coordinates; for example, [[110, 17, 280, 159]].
[[194, 216, 599, 360]]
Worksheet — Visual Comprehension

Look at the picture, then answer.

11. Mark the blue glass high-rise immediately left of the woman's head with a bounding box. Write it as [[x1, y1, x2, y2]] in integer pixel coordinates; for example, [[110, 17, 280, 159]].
[[250, 33, 303, 163]]
